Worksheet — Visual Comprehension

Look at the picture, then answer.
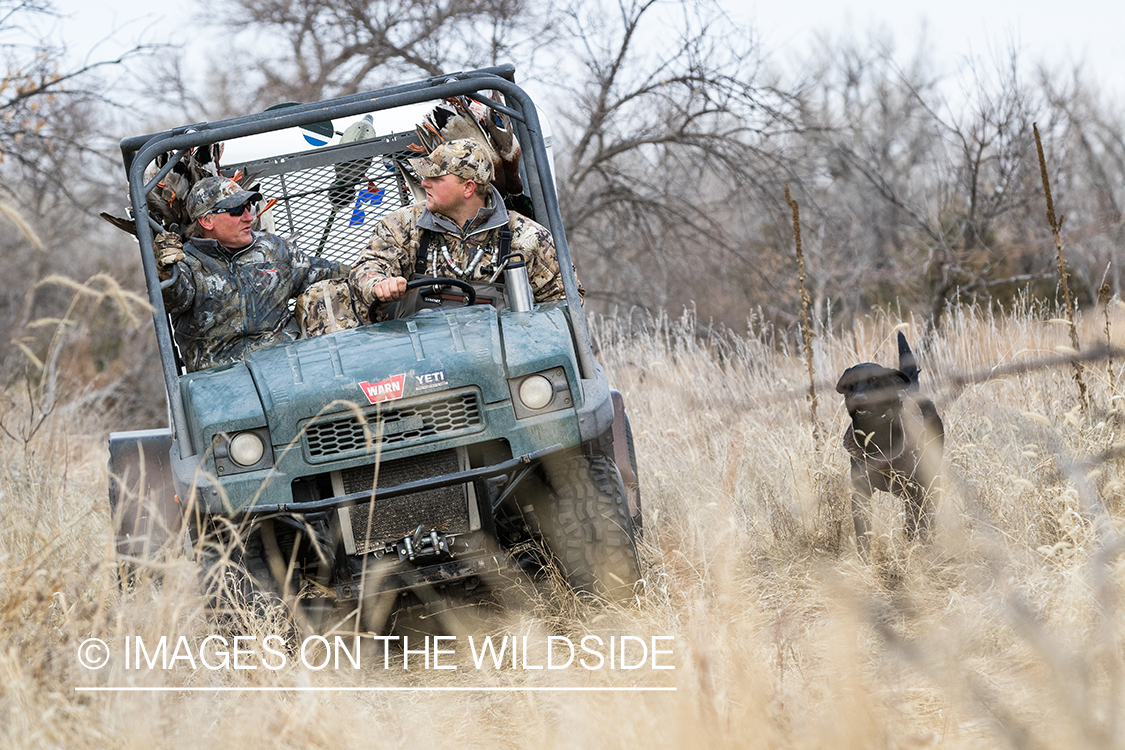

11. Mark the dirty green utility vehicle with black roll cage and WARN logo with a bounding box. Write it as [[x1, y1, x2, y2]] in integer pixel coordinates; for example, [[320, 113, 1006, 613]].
[[110, 67, 640, 602]]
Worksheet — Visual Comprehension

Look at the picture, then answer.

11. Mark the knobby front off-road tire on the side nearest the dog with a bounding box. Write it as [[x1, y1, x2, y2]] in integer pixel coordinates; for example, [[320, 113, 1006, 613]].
[[537, 453, 640, 602]]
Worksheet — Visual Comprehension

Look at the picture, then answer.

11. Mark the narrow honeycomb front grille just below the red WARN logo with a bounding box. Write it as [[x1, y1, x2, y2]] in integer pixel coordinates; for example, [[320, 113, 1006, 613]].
[[305, 391, 484, 460]]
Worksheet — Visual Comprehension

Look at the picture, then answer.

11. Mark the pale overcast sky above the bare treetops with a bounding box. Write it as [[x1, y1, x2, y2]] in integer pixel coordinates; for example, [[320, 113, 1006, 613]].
[[50, 0, 1125, 98]]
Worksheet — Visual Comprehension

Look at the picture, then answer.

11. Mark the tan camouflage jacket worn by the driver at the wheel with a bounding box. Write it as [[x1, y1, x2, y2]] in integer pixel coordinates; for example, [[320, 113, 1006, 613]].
[[350, 186, 580, 309]]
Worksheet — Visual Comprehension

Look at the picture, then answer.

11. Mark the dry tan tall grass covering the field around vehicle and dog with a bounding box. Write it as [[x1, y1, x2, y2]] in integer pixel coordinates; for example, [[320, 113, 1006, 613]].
[[0, 308, 1125, 749]]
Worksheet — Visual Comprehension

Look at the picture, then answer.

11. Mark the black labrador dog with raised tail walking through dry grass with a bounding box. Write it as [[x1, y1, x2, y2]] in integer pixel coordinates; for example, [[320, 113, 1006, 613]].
[[836, 331, 945, 554]]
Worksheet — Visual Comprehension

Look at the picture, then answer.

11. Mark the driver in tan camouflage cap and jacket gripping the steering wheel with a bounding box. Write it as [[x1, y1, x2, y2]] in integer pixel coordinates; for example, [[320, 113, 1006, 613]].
[[350, 138, 565, 310]]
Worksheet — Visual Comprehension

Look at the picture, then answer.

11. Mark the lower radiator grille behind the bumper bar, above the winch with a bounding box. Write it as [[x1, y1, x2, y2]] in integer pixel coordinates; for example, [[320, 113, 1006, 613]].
[[338, 449, 469, 554]]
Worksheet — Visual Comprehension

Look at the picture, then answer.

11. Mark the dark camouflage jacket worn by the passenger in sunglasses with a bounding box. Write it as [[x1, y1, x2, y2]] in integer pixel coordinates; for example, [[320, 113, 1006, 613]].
[[164, 232, 348, 371]]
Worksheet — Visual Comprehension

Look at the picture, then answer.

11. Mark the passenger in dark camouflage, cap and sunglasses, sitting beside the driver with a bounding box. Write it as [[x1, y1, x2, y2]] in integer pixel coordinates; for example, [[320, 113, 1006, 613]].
[[154, 177, 348, 371]]
